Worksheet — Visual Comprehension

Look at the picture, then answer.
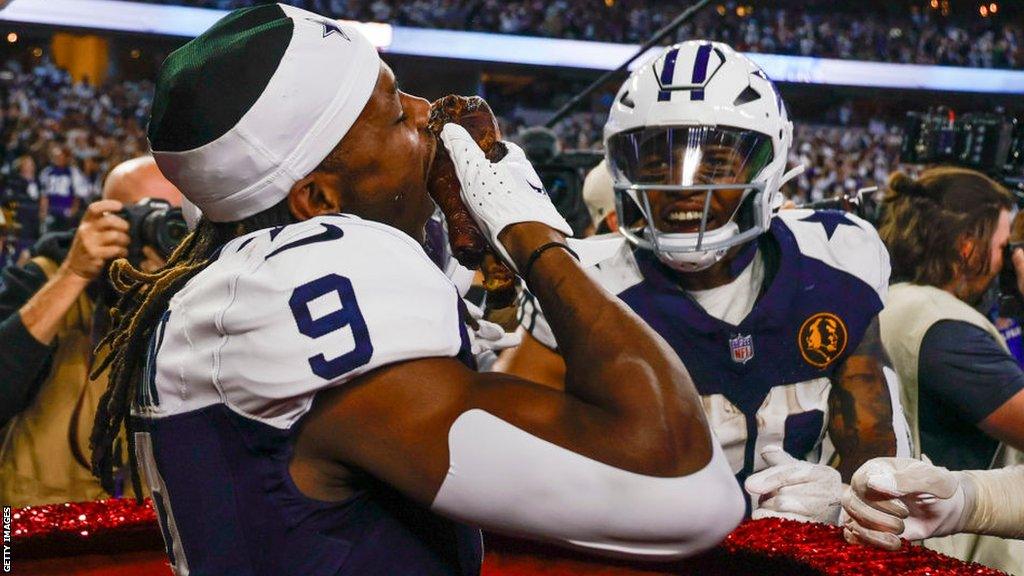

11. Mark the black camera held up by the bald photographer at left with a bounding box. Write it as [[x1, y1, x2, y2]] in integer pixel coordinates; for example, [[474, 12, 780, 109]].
[[117, 198, 188, 263]]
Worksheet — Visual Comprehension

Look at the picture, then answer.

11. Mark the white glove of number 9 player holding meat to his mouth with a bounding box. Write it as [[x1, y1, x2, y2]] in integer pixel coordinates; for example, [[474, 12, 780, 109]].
[[441, 124, 572, 270]]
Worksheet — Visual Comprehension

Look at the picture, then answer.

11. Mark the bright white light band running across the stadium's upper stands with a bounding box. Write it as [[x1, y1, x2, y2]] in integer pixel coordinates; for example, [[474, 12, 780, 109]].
[[0, 0, 1024, 94]]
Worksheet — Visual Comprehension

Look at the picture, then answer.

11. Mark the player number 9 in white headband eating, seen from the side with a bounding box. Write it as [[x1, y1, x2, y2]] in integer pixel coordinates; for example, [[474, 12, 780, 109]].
[[86, 4, 742, 576]]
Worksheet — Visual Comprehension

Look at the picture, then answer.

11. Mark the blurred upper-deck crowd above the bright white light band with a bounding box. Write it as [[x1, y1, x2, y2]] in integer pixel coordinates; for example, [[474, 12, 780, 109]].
[[132, 0, 1024, 69]]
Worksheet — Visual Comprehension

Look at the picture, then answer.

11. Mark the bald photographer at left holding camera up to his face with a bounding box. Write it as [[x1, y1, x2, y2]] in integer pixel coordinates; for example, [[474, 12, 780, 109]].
[[0, 157, 184, 506]]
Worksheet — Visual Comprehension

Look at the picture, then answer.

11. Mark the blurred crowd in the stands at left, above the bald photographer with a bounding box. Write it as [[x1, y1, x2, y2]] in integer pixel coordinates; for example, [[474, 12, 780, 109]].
[[0, 58, 153, 260]]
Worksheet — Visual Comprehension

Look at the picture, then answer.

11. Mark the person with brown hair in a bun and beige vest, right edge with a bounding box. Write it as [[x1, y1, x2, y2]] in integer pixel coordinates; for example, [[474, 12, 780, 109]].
[[845, 167, 1024, 573]]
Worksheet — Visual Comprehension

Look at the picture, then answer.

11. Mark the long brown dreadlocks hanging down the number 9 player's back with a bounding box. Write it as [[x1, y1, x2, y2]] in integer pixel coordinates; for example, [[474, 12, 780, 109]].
[[89, 198, 296, 499]]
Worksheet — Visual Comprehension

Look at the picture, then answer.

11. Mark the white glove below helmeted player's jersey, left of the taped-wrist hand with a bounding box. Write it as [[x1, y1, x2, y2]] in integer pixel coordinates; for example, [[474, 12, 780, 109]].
[[743, 445, 843, 524]]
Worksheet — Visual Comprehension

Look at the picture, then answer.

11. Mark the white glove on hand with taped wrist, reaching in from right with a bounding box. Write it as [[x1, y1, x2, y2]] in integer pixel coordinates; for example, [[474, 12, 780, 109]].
[[843, 458, 966, 550]]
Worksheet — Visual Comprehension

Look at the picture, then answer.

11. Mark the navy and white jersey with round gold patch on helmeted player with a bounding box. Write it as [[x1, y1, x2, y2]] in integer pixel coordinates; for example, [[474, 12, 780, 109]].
[[519, 210, 909, 480]]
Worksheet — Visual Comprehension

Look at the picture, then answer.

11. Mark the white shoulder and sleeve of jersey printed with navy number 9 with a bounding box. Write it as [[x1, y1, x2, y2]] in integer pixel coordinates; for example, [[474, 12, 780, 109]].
[[168, 216, 467, 427]]
